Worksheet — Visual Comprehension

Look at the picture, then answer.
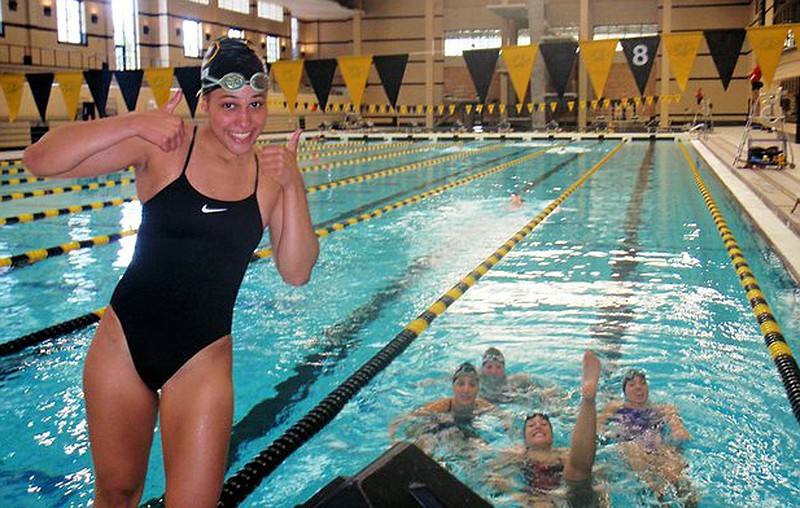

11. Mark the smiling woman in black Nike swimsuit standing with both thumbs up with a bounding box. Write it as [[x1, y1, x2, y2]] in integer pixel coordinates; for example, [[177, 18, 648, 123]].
[[24, 38, 319, 507]]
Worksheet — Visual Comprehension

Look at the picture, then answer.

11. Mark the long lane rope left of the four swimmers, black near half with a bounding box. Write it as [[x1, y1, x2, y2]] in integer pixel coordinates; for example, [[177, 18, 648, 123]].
[[217, 139, 627, 508]]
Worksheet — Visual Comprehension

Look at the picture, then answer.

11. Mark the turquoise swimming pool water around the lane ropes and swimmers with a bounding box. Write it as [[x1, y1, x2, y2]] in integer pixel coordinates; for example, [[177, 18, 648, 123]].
[[0, 139, 800, 507]]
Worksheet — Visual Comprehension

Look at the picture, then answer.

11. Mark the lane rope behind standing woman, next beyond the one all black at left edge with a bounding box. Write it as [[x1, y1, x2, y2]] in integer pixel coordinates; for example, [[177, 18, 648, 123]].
[[0, 145, 505, 270]]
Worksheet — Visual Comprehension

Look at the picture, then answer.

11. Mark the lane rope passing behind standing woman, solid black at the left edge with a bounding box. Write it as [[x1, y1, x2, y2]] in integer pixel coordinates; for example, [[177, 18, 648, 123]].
[[0, 145, 561, 357]]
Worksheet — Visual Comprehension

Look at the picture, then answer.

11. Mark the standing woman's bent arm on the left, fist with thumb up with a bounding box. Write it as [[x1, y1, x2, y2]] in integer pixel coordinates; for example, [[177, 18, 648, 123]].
[[22, 92, 186, 178]]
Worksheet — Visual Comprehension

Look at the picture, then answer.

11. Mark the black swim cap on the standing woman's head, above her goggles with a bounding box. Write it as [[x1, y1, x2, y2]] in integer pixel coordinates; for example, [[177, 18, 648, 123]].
[[200, 37, 265, 94]]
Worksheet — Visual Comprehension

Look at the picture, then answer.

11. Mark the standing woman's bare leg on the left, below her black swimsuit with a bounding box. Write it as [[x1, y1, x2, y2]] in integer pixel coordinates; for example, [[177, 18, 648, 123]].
[[83, 307, 158, 508]]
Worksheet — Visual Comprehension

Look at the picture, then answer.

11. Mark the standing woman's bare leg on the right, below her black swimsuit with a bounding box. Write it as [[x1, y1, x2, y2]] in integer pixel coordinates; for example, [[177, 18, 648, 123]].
[[161, 336, 233, 508]]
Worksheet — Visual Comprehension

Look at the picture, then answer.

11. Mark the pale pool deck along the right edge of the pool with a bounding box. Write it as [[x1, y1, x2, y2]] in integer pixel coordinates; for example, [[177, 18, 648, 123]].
[[692, 127, 800, 284]]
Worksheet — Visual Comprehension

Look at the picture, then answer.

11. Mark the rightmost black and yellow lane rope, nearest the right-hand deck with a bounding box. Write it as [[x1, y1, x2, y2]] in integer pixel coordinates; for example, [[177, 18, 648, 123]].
[[678, 143, 800, 423]]
